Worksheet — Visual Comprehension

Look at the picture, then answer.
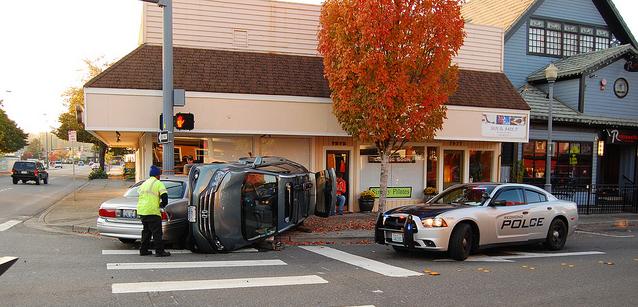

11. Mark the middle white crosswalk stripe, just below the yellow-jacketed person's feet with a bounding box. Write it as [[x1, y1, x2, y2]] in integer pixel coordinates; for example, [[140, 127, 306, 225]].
[[106, 259, 287, 270]]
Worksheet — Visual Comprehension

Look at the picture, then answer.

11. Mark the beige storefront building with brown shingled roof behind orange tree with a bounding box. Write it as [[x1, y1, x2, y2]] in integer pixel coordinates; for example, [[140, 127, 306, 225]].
[[83, 0, 530, 211]]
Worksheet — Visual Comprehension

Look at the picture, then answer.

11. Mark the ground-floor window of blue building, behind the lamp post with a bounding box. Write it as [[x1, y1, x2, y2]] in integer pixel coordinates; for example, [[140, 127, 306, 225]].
[[523, 141, 593, 184]]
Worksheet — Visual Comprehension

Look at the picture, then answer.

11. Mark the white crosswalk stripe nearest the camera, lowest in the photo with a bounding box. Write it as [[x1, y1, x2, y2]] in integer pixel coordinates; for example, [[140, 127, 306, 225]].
[[111, 275, 328, 294]]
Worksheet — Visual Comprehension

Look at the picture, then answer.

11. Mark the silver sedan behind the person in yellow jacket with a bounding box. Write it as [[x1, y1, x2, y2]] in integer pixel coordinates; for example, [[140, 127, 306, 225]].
[[97, 176, 189, 247]]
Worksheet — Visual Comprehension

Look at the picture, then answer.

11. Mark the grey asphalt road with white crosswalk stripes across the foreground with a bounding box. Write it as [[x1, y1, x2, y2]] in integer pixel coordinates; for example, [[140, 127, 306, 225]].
[[0, 167, 638, 307]]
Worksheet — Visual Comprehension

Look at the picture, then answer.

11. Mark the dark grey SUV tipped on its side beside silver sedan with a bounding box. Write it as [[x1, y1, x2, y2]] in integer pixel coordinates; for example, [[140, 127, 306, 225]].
[[188, 157, 337, 253]]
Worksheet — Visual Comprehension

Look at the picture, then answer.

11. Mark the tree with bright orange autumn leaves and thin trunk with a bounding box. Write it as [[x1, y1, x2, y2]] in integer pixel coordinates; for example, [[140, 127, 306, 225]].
[[318, 0, 465, 212]]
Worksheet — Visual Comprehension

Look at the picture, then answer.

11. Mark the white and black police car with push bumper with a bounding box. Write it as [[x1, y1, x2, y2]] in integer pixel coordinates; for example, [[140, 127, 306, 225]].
[[375, 183, 578, 261]]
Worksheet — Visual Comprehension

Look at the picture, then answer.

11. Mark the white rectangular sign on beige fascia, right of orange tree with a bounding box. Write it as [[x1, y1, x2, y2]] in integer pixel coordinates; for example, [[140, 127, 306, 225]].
[[482, 113, 527, 138]]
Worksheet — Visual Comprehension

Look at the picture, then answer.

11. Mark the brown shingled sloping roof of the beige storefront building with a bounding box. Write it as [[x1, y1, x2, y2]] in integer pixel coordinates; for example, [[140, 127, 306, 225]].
[[84, 45, 529, 110]]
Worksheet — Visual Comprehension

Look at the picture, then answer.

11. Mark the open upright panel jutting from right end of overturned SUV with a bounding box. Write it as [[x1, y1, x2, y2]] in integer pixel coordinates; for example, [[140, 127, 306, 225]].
[[311, 168, 337, 217]]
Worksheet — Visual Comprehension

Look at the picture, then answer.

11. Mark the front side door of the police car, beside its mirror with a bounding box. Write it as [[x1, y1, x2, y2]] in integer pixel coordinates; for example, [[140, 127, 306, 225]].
[[490, 188, 530, 243]]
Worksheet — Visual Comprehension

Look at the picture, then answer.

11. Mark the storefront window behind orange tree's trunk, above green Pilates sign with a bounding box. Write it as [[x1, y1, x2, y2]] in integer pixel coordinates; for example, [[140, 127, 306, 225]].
[[356, 145, 424, 198]]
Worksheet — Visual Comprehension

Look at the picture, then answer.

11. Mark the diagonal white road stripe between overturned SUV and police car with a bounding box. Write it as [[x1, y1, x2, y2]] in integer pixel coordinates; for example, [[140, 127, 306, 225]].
[[300, 246, 423, 277]]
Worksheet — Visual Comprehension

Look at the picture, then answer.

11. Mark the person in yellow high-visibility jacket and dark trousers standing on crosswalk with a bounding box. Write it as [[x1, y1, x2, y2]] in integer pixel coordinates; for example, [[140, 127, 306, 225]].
[[137, 165, 171, 257]]
